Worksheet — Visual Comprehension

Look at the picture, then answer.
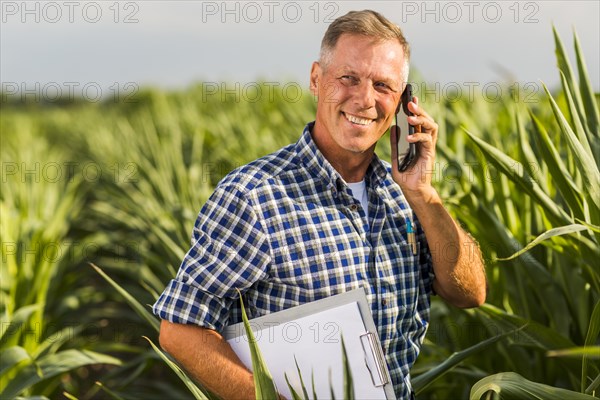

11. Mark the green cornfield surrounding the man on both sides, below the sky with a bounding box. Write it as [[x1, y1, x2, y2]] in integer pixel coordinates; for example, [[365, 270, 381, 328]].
[[0, 28, 600, 400]]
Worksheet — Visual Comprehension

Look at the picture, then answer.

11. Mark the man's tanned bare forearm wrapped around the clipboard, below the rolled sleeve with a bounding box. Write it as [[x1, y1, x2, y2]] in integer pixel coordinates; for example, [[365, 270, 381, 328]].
[[160, 321, 255, 399]]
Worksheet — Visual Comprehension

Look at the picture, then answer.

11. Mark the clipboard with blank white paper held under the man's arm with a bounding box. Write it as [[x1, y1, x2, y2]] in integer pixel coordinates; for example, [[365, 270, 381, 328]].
[[222, 288, 396, 399]]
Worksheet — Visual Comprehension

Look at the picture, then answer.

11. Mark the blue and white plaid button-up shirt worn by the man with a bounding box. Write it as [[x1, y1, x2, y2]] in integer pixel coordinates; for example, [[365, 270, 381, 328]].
[[153, 123, 433, 398]]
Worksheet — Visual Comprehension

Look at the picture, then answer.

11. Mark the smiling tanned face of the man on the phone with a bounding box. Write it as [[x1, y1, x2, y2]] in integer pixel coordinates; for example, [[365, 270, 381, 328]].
[[311, 34, 404, 162]]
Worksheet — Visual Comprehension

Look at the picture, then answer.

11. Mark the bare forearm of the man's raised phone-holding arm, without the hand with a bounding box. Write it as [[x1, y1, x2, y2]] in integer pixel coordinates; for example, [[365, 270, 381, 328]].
[[409, 189, 486, 307]]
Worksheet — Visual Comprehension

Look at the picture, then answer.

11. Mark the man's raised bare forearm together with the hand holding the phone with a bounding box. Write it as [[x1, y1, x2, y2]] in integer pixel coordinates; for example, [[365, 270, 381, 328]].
[[390, 97, 487, 307]]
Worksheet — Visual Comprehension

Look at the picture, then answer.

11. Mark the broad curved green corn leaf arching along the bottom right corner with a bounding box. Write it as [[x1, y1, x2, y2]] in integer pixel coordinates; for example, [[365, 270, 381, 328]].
[[469, 372, 595, 400]]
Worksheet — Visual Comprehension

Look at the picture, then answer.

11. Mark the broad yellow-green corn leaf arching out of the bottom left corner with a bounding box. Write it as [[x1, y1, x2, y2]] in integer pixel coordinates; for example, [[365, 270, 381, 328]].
[[0, 349, 121, 399]]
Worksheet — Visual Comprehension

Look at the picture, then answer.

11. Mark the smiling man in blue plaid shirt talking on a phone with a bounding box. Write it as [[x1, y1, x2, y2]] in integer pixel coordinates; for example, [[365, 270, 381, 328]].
[[154, 11, 486, 399]]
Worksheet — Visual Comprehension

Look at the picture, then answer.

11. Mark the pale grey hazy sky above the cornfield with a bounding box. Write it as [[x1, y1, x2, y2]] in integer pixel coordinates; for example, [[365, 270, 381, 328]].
[[0, 0, 600, 100]]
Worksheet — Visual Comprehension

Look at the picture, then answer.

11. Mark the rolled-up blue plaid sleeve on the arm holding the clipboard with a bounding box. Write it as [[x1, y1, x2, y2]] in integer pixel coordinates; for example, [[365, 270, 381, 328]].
[[153, 186, 270, 331]]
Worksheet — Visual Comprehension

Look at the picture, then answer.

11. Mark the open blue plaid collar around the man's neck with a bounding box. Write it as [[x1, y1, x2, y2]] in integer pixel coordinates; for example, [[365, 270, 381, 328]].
[[296, 121, 388, 190]]
